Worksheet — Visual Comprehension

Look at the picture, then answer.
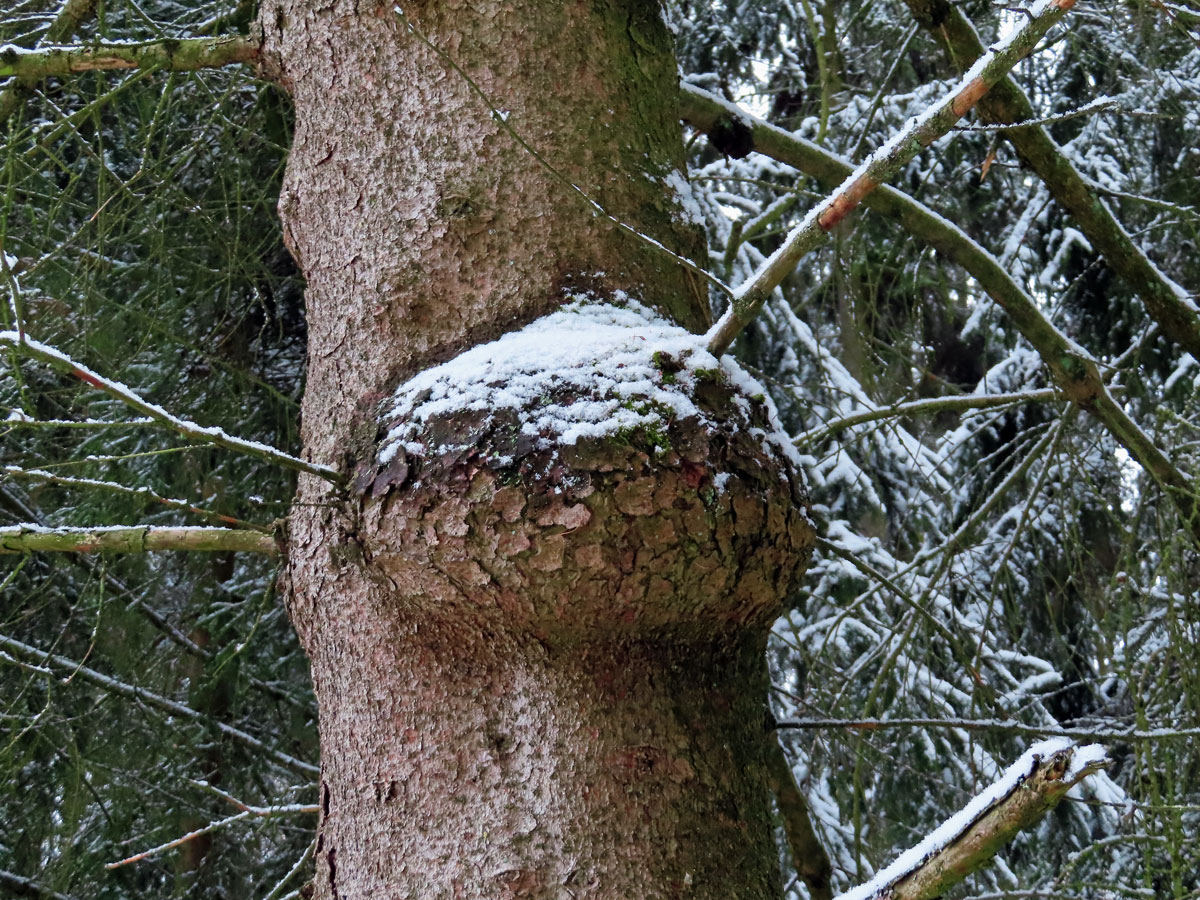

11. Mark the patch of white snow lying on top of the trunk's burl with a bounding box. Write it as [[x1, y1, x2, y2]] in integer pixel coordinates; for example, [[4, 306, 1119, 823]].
[[378, 292, 800, 468]]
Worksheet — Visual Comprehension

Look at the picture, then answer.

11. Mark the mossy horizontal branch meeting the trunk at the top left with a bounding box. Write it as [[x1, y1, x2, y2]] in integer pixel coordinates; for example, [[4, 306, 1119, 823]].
[[0, 35, 260, 82]]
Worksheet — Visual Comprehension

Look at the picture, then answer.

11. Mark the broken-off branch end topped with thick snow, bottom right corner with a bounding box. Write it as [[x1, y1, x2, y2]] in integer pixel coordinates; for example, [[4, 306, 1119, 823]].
[[838, 740, 1109, 900]]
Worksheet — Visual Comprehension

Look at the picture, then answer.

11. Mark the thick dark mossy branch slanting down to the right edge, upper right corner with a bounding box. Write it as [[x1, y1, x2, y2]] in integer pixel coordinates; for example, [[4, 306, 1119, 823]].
[[905, 0, 1200, 358]]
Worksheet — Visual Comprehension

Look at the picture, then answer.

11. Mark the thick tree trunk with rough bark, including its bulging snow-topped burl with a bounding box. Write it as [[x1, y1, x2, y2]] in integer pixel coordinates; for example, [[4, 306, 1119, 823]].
[[255, 0, 812, 900]]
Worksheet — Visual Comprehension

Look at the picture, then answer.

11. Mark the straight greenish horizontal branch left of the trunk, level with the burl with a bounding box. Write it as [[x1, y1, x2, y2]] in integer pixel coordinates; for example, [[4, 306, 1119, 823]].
[[0, 524, 280, 556]]
